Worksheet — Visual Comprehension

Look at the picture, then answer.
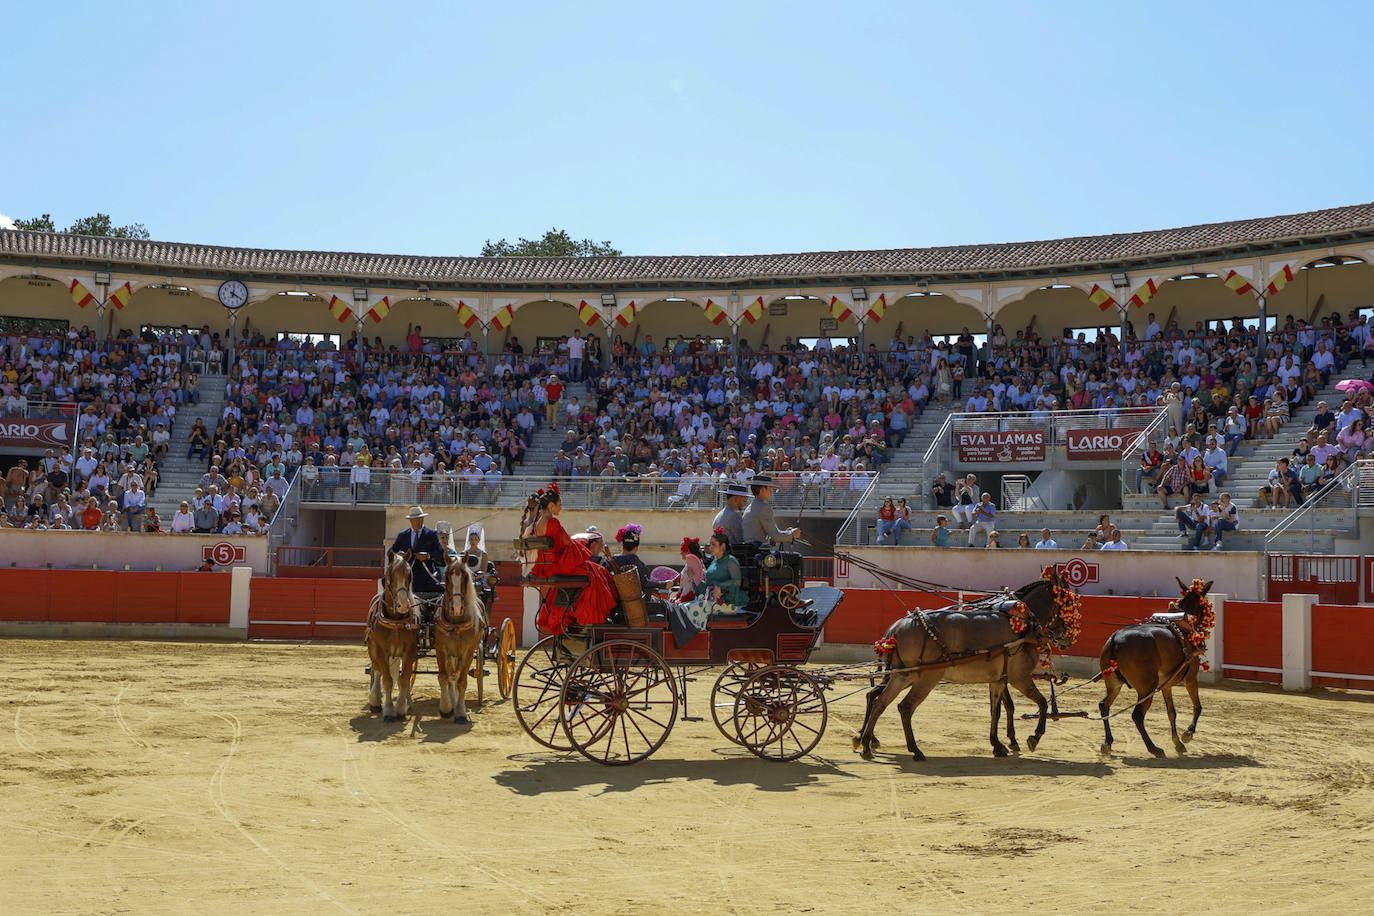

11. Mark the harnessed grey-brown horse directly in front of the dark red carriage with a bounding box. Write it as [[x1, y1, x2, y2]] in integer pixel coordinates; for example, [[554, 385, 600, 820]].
[[855, 566, 1079, 761]]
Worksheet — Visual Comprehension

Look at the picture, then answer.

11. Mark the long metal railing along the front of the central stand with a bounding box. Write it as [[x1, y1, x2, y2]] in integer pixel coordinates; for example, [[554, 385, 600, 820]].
[[293, 468, 878, 511]]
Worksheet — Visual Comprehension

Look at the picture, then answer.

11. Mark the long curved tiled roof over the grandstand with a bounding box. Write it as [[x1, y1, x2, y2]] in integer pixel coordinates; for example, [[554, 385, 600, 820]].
[[0, 203, 1374, 287]]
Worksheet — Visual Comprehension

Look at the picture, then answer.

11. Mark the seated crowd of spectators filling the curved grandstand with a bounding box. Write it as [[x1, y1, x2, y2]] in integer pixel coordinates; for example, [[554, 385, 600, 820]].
[[0, 302, 1374, 544]]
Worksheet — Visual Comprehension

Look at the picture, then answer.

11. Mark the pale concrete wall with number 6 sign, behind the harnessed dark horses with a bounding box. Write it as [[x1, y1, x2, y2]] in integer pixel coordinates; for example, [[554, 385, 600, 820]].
[[835, 547, 1264, 602]]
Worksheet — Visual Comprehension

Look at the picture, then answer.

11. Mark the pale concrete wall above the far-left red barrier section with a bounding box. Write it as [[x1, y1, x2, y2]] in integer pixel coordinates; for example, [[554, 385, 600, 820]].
[[0, 529, 268, 575]]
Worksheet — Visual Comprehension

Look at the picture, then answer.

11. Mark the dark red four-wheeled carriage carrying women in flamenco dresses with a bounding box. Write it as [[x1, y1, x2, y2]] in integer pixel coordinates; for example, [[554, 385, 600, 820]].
[[513, 537, 842, 765]]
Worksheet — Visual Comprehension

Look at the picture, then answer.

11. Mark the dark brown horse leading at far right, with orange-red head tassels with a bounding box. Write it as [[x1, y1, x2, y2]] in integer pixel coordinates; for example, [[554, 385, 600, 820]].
[[1098, 577, 1213, 757]]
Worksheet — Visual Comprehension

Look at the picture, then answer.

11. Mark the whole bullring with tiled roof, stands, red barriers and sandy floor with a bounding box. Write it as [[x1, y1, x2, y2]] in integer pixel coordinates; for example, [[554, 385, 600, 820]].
[[0, 205, 1374, 912]]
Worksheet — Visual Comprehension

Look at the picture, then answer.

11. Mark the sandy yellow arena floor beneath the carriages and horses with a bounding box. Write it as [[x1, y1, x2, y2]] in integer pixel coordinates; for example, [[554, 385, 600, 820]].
[[0, 640, 1374, 913]]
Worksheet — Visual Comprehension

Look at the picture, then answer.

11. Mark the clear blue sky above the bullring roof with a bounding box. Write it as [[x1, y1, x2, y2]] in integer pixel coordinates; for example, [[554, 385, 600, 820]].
[[0, 0, 1374, 254]]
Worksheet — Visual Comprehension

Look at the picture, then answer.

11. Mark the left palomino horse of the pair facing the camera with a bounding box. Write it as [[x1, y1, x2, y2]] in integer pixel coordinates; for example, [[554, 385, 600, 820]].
[[367, 551, 420, 722]]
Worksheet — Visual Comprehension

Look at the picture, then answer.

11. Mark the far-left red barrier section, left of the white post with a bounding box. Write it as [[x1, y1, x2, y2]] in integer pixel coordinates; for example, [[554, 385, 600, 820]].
[[0, 570, 231, 625]]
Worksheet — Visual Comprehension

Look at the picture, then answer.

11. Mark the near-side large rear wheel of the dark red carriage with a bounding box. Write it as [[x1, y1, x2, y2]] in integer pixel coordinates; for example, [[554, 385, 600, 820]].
[[559, 640, 677, 766]]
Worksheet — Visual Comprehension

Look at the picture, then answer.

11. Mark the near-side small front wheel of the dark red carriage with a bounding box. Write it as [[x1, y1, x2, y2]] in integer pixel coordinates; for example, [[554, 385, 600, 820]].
[[735, 665, 829, 761]]
